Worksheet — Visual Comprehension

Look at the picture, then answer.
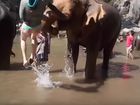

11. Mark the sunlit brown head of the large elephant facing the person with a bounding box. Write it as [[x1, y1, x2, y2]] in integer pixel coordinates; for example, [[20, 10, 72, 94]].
[[43, 0, 73, 31]]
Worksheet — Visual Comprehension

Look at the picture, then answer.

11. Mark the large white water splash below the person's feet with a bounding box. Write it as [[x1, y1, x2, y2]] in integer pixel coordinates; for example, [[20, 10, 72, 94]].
[[32, 63, 62, 88]]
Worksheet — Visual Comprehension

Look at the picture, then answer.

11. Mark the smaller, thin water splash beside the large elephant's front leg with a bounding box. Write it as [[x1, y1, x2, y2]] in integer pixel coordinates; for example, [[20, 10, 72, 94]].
[[64, 56, 74, 78]]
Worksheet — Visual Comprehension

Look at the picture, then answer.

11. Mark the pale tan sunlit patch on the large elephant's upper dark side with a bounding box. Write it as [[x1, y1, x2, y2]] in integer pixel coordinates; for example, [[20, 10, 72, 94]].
[[85, 4, 105, 25]]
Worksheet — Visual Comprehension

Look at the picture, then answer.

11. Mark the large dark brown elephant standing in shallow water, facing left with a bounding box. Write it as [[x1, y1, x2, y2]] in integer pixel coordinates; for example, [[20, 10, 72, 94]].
[[44, 0, 121, 81]]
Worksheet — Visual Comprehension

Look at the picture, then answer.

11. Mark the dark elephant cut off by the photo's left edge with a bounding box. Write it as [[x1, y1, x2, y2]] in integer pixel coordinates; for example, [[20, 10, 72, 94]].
[[0, 2, 16, 70]]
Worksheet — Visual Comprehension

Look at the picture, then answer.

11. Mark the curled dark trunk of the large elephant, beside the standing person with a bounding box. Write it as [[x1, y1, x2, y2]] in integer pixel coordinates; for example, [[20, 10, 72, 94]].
[[43, 1, 70, 35]]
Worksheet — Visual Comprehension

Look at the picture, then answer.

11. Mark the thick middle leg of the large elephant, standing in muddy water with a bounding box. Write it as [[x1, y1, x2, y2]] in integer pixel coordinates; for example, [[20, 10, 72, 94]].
[[85, 49, 98, 80]]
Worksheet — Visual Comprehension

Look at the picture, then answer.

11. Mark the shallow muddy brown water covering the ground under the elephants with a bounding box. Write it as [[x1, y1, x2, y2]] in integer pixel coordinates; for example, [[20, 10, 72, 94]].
[[0, 37, 140, 105]]
